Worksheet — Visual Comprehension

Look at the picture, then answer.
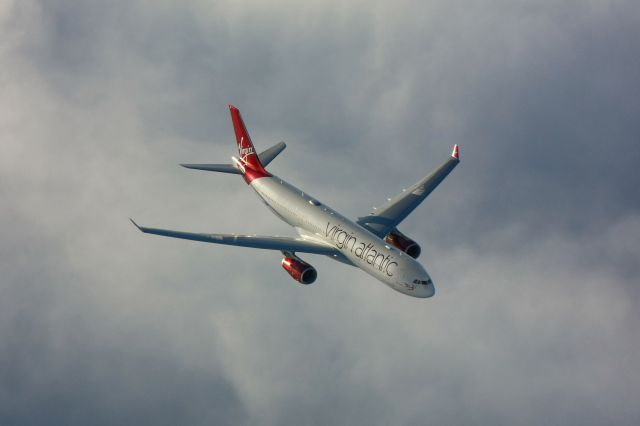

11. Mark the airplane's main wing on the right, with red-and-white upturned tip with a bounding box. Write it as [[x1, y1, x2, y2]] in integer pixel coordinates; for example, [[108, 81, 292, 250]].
[[357, 145, 460, 238]]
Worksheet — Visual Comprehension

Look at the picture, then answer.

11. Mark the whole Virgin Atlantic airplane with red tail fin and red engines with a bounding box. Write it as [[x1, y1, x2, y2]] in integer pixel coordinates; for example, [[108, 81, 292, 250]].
[[130, 105, 460, 298]]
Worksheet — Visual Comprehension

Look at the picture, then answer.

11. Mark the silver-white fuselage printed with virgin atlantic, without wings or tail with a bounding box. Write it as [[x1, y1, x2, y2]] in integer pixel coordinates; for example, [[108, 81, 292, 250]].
[[250, 176, 435, 297]]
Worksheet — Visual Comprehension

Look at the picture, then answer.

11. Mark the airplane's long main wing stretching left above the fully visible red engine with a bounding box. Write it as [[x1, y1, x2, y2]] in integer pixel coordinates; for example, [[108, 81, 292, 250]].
[[130, 219, 338, 255]]
